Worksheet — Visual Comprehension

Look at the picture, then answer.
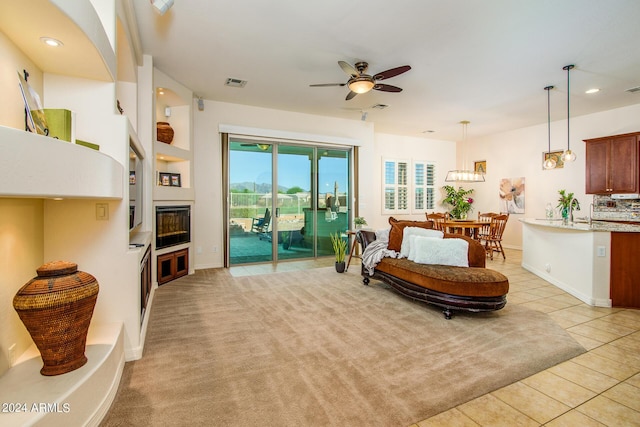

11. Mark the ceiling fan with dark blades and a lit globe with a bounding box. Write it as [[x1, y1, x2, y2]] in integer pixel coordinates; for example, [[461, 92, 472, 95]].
[[309, 61, 411, 101]]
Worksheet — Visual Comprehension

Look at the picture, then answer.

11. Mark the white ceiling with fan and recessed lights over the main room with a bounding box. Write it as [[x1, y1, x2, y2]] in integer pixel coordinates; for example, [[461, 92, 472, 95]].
[[133, 0, 640, 140]]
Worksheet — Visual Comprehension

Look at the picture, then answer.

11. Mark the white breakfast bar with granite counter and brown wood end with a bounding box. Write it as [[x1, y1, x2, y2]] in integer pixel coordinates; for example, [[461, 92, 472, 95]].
[[520, 218, 640, 307]]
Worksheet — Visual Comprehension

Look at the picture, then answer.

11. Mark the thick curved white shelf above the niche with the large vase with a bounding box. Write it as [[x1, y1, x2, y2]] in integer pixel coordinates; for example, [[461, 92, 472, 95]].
[[0, 126, 124, 199]]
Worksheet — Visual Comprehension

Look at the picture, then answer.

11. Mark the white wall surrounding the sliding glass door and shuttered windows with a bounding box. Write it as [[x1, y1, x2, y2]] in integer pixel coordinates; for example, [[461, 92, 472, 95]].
[[194, 101, 455, 269]]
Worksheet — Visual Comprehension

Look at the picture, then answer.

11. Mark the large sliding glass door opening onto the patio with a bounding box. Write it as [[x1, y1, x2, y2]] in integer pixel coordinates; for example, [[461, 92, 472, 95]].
[[227, 138, 351, 265]]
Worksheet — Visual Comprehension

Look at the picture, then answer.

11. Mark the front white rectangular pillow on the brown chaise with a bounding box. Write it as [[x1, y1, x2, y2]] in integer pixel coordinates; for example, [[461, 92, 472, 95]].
[[414, 236, 469, 267]]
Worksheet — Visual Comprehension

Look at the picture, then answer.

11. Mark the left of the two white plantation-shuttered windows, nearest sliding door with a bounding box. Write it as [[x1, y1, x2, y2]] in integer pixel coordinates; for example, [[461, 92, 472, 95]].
[[382, 159, 409, 214]]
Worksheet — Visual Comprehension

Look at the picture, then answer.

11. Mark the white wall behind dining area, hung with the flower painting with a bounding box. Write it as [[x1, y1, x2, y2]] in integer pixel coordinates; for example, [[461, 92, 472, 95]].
[[464, 104, 640, 248]]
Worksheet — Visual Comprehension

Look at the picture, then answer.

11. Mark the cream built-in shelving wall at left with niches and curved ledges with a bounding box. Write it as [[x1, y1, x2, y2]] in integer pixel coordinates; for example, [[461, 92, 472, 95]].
[[0, 0, 154, 425]]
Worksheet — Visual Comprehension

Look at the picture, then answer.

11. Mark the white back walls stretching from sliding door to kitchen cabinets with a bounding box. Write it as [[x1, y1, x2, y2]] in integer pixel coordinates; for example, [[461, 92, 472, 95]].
[[194, 97, 640, 269]]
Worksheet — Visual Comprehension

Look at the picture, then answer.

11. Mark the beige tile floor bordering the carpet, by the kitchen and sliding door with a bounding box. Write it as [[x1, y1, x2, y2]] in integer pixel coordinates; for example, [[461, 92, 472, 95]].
[[231, 249, 640, 427]]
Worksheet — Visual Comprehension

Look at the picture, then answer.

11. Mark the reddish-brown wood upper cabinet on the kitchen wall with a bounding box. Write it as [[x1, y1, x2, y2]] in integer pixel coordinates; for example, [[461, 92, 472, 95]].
[[584, 132, 640, 194]]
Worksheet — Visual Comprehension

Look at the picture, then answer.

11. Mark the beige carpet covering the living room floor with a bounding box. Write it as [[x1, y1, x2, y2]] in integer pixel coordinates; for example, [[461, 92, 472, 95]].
[[102, 268, 585, 426]]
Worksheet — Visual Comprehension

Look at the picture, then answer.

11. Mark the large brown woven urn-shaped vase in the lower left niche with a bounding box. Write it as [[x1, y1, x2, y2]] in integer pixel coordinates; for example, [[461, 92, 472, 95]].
[[13, 261, 99, 376]]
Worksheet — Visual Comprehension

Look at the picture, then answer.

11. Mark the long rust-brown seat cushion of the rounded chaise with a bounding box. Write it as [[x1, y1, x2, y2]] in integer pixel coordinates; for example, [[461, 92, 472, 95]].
[[376, 258, 509, 297]]
